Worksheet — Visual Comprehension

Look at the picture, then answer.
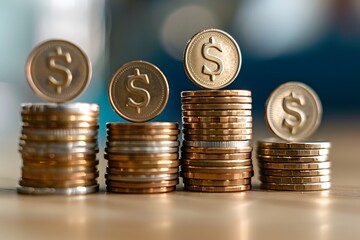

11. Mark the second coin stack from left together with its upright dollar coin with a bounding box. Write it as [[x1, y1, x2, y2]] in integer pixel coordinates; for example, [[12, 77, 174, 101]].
[[104, 61, 180, 193]]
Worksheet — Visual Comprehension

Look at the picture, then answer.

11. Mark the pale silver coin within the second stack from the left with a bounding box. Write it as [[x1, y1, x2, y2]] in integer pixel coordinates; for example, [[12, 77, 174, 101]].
[[105, 147, 179, 153]]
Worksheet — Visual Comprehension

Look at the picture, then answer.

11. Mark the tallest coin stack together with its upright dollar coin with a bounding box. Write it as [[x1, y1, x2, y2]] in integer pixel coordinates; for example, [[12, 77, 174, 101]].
[[181, 29, 253, 192]]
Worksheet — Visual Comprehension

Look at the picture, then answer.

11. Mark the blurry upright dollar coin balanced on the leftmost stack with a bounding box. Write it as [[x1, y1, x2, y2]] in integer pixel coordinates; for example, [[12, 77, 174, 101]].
[[26, 40, 91, 103]]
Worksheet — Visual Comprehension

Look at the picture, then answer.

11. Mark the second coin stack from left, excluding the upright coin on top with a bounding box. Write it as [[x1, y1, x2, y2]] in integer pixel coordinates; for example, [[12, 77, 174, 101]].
[[105, 122, 180, 193]]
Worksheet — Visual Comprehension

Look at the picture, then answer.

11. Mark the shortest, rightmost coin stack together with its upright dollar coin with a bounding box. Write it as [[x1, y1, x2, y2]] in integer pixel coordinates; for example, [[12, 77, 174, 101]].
[[257, 82, 331, 191]]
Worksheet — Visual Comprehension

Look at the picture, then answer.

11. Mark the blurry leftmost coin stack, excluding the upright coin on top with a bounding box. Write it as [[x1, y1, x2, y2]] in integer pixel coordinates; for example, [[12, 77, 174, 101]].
[[18, 103, 99, 194]]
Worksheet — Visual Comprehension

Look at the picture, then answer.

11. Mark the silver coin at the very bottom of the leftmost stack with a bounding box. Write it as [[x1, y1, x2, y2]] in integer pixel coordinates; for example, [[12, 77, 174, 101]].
[[17, 184, 99, 195]]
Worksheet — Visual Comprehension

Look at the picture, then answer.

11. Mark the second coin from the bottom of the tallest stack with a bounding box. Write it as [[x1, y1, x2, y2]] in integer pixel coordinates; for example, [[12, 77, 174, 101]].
[[183, 178, 251, 187]]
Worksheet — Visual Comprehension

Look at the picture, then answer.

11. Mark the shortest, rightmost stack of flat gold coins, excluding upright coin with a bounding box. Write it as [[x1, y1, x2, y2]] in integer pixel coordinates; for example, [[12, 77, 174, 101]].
[[257, 139, 331, 191]]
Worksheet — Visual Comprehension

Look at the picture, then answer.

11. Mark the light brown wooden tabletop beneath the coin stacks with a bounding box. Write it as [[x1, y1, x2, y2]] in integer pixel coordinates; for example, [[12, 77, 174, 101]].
[[0, 118, 360, 240]]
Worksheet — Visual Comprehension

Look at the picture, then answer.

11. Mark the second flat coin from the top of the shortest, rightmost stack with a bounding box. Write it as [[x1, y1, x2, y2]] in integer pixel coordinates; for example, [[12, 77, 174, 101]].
[[257, 148, 329, 157]]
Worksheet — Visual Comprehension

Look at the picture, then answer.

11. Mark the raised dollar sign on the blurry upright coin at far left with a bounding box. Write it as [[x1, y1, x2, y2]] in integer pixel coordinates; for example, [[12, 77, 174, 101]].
[[48, 47, 72, 94]]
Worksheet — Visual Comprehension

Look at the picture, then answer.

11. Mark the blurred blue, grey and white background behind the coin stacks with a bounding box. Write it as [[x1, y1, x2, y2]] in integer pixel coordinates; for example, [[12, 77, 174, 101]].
[[0, 0, 360, 185]]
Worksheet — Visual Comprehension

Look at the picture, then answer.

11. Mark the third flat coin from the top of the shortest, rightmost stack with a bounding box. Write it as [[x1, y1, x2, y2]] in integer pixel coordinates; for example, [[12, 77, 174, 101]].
[[257, 155, 329, 163]]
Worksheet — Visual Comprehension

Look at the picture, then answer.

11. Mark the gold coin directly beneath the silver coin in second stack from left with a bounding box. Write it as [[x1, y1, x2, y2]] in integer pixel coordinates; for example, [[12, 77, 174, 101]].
[[104, 152, 179, 162]]
